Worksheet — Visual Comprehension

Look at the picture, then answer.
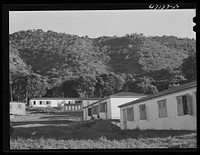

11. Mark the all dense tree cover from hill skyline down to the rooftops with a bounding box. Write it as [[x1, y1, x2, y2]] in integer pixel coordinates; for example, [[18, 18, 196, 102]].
[[9, 29, 196, 101]]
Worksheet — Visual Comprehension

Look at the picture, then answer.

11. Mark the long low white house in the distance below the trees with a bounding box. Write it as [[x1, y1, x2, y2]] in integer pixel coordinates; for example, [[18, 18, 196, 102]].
[[29, 98, 99, 111]]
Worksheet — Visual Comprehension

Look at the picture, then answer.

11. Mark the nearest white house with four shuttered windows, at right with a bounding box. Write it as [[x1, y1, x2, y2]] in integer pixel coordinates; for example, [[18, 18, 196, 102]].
[[119, 81, 196, 130]]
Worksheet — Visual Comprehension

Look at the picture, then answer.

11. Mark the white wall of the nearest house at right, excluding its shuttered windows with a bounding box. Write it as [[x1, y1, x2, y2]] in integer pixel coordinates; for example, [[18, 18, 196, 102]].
[[120, 88, 196, 130]]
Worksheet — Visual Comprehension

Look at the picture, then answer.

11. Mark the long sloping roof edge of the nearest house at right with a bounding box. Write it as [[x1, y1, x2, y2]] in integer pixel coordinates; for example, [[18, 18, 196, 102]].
[[118, 81, 197, 108]]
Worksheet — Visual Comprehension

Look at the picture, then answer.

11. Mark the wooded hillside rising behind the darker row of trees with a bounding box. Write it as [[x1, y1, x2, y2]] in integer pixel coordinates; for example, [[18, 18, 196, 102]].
[[9, 29, 196, 100]]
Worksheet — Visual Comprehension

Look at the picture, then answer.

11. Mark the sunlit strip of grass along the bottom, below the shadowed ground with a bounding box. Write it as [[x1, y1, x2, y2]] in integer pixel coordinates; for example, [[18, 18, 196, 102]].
[[10, 134, 196, 149]]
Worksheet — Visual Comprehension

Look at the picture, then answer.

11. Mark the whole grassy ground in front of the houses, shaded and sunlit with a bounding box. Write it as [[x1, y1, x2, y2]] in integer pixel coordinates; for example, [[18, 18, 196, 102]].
[[10, 108, 196, 149]]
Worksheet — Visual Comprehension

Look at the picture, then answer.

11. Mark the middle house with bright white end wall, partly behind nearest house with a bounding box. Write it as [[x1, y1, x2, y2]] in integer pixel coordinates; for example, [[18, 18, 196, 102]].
[[83, 92, 146, 120]]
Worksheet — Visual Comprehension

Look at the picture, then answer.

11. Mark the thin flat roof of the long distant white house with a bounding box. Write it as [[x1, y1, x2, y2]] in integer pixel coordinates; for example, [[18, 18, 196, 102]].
[[30, 97, 101, 100]]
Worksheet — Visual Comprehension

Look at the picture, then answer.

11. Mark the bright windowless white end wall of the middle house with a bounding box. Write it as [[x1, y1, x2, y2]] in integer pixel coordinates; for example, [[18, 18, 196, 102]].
[[111, 97, 139, 119]]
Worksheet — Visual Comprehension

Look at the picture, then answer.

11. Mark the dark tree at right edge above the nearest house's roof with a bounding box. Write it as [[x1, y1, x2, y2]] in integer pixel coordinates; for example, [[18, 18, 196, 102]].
[[181, 53, 197, 81]]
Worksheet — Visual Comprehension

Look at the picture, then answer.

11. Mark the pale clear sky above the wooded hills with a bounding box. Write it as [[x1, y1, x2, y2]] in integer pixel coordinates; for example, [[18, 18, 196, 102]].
[[9, 9, 196, 39]]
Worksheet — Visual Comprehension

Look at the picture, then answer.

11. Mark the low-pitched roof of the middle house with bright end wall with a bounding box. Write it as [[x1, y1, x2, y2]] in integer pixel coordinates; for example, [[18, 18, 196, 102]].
[[83, 92, 147, 109]]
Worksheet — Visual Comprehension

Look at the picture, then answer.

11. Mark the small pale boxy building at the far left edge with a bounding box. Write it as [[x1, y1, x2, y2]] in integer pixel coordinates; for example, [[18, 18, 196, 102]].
[[10, 102, 26, 115]]
